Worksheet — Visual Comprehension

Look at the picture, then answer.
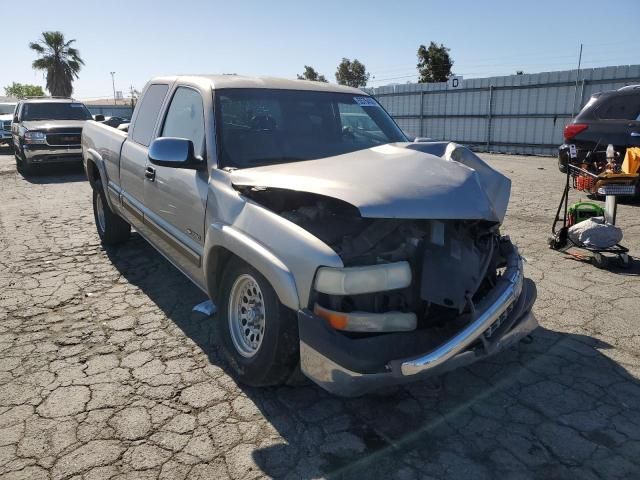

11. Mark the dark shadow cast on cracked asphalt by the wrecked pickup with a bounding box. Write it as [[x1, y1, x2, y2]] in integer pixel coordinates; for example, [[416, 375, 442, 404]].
[[107, 235, 640, 479]]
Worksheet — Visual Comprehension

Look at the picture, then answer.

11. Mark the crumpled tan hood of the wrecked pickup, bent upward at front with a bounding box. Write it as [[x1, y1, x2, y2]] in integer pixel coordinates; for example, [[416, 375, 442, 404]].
[[231, 142, 511, 223]]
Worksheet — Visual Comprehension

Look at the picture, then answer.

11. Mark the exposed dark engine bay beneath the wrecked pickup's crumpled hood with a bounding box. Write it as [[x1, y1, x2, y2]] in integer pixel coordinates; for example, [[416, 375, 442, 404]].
[[235, 187, 504, 328]]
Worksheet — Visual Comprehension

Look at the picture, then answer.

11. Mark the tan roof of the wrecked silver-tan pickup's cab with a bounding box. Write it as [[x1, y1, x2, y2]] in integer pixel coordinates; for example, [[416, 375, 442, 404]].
[[152, 74, 367, 95]]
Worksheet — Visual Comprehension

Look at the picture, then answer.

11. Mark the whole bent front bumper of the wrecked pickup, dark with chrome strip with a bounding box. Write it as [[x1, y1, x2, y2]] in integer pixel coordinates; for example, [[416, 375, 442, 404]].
[[298, 242, 538, 396]]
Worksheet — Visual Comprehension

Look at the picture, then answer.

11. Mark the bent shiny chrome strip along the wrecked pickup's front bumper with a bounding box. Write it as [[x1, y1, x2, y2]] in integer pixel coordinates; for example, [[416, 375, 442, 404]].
[[400, 247, 523, 375]]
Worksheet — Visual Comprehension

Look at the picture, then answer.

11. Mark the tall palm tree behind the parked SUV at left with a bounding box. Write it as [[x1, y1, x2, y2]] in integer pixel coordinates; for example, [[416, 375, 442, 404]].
[[29, 32, 84, 97]]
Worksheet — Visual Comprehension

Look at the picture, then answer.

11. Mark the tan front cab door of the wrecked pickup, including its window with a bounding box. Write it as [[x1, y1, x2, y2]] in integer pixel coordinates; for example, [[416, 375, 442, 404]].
[[144, 86, 209, 285]]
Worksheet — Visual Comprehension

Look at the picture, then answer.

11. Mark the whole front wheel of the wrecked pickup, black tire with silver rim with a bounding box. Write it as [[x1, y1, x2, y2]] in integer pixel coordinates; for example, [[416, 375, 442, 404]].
[[214, 257, 299, 387]]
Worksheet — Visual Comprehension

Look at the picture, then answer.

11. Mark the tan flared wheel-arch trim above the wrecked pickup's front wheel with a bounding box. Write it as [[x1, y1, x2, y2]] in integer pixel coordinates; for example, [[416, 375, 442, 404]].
[[203, 223, 300, 310]]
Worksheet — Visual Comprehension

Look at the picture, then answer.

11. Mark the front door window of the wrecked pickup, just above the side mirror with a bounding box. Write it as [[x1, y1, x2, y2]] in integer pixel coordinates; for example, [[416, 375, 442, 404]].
[[160, 87, 204, 155]]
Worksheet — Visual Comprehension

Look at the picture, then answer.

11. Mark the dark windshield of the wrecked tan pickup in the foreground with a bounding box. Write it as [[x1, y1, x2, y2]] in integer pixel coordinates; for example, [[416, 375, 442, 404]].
[[216, 88, 407, 168]]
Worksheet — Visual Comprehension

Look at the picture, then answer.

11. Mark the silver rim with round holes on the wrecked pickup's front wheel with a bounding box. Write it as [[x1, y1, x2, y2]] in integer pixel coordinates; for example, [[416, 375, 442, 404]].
[[229, 274, 266, 358]]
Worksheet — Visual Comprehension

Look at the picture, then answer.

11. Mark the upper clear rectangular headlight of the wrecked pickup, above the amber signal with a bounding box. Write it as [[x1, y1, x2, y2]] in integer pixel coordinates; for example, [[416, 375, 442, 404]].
[[316, 262, 411, 295]]
